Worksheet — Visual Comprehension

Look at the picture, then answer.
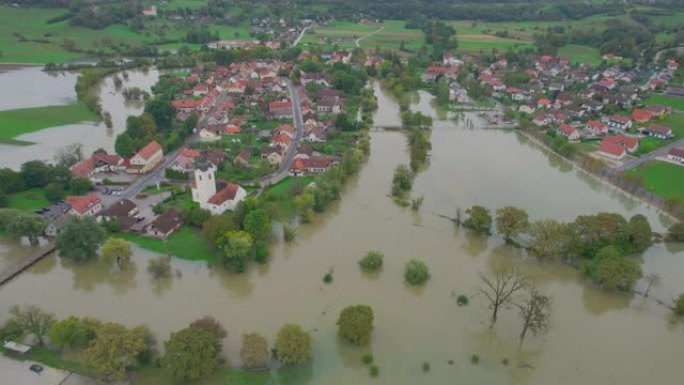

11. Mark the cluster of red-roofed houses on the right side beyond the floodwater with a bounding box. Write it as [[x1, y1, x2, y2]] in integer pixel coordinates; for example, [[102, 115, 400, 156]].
[[438, 49, 678, 160]]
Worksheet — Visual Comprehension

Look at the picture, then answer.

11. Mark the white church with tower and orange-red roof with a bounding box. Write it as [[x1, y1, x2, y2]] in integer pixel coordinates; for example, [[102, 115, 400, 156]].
[[192, 166, 247, 215]]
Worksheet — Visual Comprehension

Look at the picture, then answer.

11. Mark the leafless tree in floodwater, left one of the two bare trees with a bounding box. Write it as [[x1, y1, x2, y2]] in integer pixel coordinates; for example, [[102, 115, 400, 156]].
[[479, 264, 527, 329]]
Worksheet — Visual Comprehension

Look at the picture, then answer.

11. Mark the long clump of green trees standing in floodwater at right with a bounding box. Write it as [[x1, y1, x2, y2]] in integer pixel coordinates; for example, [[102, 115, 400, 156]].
[[456, 206, 653, 290]]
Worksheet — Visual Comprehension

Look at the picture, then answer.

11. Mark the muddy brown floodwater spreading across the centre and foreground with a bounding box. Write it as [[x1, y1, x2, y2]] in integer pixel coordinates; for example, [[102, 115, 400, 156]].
[[0, 82, 684, 385]]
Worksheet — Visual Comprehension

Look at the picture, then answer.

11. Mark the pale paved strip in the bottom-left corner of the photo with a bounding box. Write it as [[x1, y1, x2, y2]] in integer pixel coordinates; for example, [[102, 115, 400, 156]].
[[0, 355, 97, 385]]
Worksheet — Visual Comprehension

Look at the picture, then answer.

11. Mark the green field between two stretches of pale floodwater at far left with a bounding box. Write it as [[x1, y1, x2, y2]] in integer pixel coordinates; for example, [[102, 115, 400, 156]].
[[0, 103, 98, 143]]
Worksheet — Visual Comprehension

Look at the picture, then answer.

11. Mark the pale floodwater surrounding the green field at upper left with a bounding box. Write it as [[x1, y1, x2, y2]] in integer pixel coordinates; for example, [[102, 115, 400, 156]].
[[0, 67, 159, 169]]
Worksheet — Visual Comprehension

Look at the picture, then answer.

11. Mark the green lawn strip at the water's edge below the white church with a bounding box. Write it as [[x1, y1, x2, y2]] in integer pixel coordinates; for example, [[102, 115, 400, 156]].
[[117, 226, 216, 265]]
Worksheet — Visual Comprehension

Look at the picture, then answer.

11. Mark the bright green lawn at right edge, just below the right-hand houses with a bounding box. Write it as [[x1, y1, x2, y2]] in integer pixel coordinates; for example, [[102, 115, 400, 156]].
[[628, 162, 684, 200]]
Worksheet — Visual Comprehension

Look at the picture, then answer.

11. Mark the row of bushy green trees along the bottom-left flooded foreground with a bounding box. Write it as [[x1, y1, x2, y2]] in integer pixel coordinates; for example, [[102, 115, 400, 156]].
[[0, 306, 314, 382]]
